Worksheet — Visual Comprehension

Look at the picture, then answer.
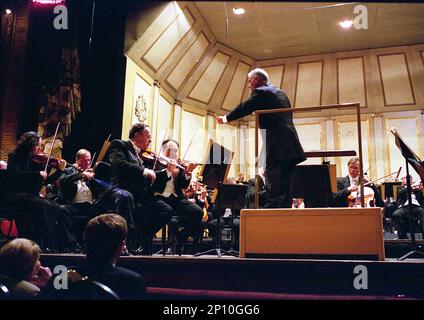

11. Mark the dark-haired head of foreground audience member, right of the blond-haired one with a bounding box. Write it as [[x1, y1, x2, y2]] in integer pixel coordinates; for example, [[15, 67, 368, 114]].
[[84, 214, 128, 263]]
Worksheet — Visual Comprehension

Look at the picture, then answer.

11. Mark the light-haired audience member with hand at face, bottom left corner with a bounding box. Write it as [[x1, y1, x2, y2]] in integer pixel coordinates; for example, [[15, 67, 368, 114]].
[[0, 238, 52, 299]]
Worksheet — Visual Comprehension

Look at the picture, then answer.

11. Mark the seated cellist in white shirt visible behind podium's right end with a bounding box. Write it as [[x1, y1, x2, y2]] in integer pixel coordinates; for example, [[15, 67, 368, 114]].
[[334, 157, 384, 207]]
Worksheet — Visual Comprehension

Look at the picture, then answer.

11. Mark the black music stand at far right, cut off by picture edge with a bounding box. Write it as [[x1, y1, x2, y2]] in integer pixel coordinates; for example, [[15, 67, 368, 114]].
[[390, 128, 424, 261]]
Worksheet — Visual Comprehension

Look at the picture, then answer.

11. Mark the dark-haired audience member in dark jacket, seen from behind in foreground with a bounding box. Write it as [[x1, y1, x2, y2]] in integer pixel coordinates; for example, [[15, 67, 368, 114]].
[[84, 214, 146, 300]]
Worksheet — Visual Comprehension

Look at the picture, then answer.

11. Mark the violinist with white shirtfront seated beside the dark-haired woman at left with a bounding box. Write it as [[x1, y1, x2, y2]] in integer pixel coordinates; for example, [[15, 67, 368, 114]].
[[59, 149, 110, 244]]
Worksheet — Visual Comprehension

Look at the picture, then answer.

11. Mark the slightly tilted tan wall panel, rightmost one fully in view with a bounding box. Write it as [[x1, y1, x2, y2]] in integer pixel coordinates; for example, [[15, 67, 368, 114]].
[[378, 53, 415, 106]]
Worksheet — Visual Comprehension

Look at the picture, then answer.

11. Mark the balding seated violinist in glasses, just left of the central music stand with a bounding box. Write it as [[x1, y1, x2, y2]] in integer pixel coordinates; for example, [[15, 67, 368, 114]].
[[154, 139, 203, 254]]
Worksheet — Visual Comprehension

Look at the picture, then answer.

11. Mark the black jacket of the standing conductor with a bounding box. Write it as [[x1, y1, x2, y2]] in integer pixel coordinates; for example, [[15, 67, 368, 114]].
[[227, 84, 306, 166]]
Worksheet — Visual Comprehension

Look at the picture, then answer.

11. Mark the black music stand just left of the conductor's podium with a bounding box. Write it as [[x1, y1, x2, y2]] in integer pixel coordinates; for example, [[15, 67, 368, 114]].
[[194, 139, 234, 258]]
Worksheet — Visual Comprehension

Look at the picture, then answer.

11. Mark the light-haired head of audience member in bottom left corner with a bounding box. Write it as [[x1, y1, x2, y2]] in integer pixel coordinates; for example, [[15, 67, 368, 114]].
[[0, 238, 41, 280]]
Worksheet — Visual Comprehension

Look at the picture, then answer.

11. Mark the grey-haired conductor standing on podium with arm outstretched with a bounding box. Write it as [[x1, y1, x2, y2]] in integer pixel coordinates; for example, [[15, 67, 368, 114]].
[[217, 68, 306, 208]]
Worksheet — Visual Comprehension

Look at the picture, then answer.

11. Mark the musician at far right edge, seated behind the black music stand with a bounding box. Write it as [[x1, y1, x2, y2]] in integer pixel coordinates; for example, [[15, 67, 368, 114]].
[[392, 176, 424, 239]]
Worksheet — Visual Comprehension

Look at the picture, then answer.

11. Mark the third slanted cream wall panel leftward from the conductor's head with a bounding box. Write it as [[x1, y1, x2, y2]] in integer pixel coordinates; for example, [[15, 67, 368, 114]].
[[166, 32, 210, 90]]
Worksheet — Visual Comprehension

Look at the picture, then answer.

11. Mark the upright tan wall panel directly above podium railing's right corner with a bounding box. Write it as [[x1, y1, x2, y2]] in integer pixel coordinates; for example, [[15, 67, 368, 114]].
[[337, 57, 367, 106]]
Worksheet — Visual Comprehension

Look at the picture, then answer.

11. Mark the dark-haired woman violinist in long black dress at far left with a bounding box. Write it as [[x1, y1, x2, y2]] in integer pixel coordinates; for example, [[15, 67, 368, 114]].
[[5, 131, 76, 252]]
